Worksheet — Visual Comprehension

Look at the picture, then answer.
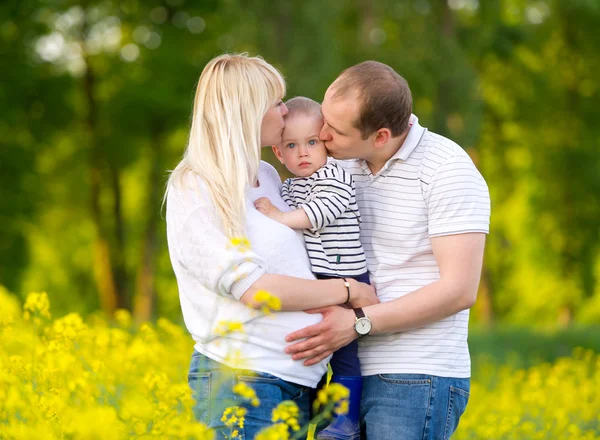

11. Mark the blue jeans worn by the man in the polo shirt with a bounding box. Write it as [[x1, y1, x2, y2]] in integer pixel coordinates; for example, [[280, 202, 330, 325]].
[[360, 374, 470, 440]]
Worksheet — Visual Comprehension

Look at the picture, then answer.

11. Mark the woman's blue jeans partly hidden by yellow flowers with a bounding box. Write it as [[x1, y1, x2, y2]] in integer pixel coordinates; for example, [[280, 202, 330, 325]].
[[188, 351, 312, 440]]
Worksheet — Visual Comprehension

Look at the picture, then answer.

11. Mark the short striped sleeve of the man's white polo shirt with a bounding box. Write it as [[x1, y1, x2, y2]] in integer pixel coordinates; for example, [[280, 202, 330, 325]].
[[425, 154, 490, 237]]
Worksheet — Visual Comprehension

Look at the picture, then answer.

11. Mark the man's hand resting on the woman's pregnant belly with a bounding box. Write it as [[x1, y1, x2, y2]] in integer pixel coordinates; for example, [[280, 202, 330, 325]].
[[285, 306, 358, 366]]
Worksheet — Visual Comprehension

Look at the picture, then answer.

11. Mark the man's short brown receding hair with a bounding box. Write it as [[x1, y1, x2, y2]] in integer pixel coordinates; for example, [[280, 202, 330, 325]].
[[332, 61, 412, 139]]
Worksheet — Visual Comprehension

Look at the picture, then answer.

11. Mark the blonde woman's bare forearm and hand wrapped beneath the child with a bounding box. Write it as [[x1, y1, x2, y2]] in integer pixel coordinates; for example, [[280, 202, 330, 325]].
[[240, 273, 379, 311]]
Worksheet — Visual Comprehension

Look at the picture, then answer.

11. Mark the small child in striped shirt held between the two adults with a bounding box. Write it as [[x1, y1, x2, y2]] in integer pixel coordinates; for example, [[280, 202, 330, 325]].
[[255, 97, 369, 440]]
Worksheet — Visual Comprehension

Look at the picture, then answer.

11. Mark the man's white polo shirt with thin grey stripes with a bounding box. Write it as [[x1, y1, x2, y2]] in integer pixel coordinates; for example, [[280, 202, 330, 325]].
[[338, 115, 490, 378]]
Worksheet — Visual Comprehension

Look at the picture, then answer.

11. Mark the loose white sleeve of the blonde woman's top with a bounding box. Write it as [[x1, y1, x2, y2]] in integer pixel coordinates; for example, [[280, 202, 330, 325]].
[[176, 193, 266, 300]]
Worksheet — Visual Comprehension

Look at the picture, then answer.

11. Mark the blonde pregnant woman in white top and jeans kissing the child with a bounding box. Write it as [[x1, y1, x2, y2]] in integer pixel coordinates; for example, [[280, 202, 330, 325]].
[[165, 55, 378, 439]]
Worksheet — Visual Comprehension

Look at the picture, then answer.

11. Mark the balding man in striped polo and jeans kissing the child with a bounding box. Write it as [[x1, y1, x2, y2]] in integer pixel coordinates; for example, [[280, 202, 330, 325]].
[[286, 61, 490, 440]]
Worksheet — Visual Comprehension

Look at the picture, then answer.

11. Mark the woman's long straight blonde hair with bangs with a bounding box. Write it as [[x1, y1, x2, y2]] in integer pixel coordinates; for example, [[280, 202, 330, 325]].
[[165, 53, 285, 237]]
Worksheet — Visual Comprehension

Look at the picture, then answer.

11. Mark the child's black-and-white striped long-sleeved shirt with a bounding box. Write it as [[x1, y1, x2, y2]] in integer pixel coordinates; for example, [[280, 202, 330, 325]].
[[281, 162, 367, 277]]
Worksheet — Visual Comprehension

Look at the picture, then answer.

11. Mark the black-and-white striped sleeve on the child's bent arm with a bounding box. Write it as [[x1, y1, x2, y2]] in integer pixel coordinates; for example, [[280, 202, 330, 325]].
[[300, 166, 355, 230]]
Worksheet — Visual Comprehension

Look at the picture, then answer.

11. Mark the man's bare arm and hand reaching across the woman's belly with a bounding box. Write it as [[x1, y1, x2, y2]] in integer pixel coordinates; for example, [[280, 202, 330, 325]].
[[286, 233, 485, 365]]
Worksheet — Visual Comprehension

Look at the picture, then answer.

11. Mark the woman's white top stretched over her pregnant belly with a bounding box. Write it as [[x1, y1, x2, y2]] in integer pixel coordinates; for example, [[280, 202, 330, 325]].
[[167, 162, 329, 387]]
